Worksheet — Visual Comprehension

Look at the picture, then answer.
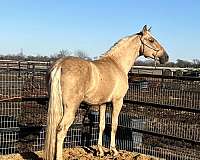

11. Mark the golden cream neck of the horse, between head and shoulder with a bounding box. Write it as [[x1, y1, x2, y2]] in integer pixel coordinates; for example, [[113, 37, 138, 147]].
[[105, 35, 141, 74]]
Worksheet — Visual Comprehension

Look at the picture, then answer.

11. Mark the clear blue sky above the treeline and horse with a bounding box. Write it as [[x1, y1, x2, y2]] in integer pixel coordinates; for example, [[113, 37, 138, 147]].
[[0, 0, 200, 61]]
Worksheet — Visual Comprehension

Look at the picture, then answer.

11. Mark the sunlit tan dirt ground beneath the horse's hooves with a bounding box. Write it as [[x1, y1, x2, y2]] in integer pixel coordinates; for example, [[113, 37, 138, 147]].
[[0, 147, 161, 160]]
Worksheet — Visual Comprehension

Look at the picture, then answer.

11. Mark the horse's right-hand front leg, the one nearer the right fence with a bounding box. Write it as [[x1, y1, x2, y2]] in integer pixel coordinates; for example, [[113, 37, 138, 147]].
[[110, 98, 123, 157]]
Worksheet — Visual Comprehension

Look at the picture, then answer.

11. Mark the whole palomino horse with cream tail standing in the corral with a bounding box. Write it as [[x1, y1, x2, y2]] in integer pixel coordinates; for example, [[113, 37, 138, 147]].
[[45, 25, 168, 160]]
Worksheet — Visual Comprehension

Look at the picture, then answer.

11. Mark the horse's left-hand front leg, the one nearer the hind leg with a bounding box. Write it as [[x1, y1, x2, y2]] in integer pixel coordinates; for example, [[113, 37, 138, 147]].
[[98, 104, 106, 157]]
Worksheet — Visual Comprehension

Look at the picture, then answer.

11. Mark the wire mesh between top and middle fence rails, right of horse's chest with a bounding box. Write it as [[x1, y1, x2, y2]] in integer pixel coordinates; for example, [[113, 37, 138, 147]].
[[125, 74, 200, 109]]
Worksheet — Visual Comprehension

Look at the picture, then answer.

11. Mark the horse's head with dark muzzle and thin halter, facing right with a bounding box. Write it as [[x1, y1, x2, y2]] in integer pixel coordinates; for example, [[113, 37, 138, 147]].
[[140, 25, 169, 64]]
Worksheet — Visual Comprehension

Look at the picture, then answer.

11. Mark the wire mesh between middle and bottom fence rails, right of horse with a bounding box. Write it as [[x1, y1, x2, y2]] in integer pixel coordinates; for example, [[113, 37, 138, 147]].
[[120, 104, 200, 142]]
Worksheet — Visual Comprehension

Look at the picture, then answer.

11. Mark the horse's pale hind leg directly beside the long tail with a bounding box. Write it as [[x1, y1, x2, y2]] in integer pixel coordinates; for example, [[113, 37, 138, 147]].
[[56, 103, 80, 160]]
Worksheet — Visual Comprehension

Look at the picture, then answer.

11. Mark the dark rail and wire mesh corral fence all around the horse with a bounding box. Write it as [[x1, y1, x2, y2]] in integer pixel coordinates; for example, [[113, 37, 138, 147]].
[[0, 62, 200, 160]]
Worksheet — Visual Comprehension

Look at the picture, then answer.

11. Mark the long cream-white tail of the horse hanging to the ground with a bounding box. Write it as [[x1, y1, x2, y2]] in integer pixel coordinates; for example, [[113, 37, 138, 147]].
[[44, 65, 63, 160]]
